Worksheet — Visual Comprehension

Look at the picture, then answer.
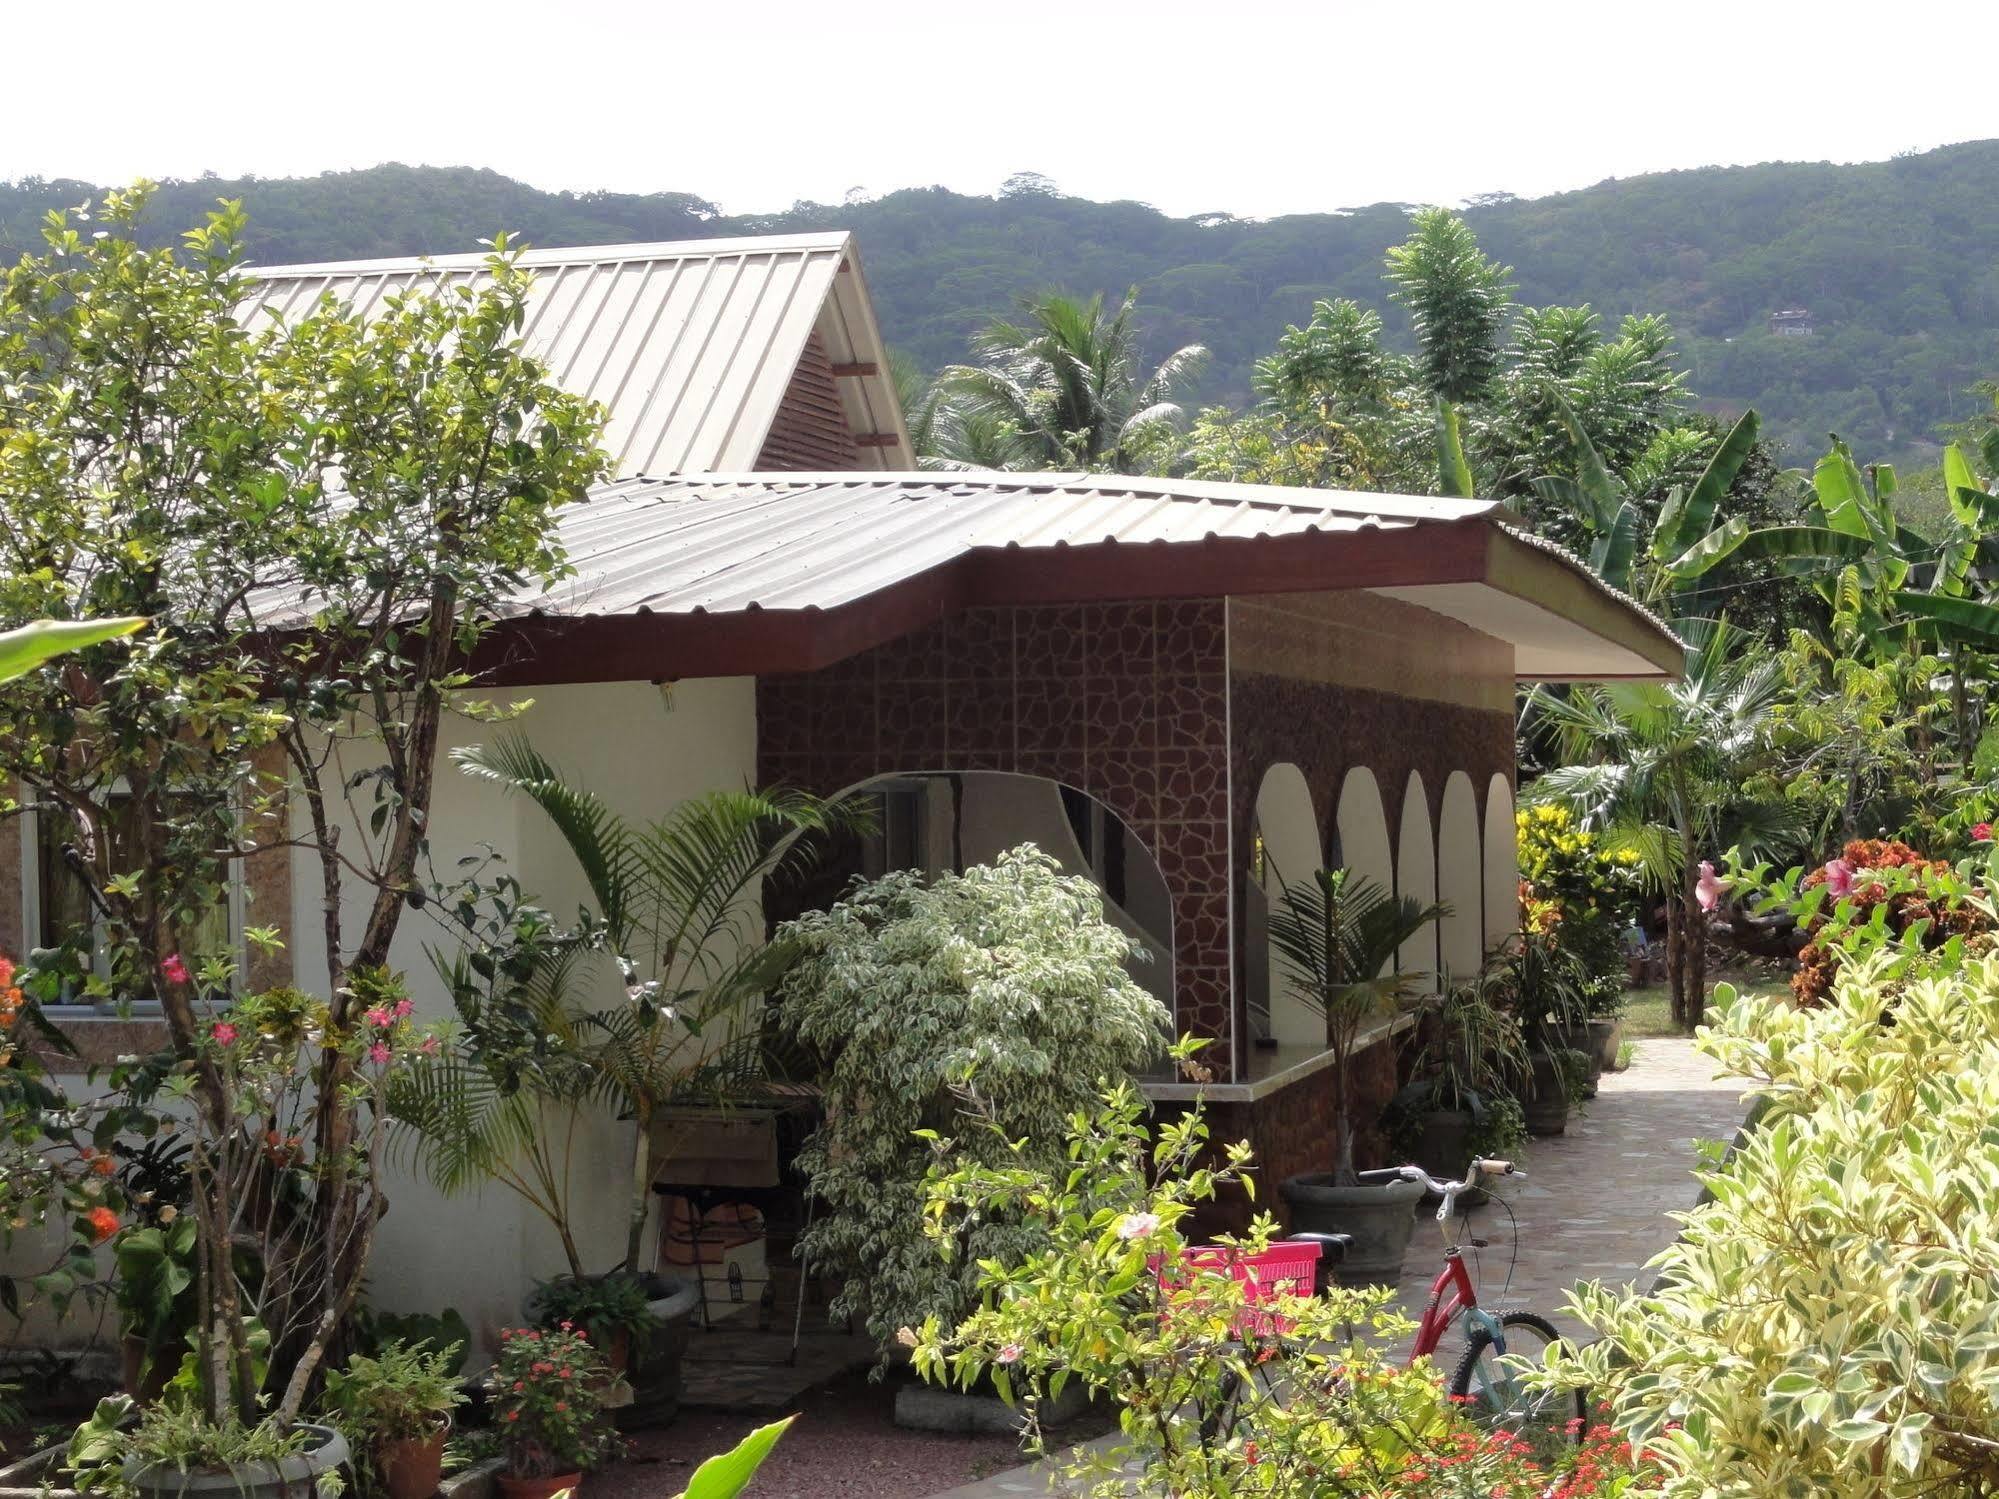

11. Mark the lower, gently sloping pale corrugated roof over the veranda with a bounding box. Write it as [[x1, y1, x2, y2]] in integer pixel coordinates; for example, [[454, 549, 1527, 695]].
[[467, 474, 1499, 616]]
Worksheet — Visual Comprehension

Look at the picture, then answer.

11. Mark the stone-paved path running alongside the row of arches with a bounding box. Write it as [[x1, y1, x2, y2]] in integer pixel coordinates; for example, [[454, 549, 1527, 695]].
[[938, 1039, 1743, 1499]]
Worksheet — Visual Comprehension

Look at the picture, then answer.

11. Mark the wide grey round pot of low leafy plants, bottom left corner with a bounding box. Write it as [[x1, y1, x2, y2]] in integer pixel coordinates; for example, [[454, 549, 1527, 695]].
[[66, 1395, 350, 1499]]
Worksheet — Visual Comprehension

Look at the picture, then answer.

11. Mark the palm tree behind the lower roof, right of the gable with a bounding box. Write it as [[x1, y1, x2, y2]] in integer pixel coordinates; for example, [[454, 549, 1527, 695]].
[[938, 288, 1207, 470]]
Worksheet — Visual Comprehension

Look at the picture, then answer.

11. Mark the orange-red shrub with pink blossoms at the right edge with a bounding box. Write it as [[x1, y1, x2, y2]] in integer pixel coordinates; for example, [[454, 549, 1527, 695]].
[[1733, 837, 1995, 1005]]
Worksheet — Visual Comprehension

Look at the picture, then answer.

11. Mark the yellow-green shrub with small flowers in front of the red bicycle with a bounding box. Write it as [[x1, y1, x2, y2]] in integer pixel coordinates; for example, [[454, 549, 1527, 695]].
[[902, 1043, 1655, 1499]]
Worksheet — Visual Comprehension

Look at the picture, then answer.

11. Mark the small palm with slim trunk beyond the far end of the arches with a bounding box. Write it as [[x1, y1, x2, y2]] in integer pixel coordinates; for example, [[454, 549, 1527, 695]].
[[1521, 620, 1789, 1029]]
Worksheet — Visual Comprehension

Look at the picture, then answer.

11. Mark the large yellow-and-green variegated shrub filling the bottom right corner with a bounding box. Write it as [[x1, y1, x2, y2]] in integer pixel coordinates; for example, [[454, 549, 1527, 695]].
[[1555, 951, 1999, 1499]]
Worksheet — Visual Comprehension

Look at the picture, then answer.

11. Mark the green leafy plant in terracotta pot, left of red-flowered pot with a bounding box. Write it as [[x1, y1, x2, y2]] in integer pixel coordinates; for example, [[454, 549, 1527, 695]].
[[326, 1343, 466, 1499]]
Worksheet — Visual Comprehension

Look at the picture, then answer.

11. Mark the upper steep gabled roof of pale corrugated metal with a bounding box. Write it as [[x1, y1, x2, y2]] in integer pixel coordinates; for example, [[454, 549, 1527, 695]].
[[244, 234, 914, 476]]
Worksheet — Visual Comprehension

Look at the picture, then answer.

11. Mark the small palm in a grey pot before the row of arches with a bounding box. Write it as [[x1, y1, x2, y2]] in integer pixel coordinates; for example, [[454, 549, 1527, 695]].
[[1269, 869, 1451, 1187]]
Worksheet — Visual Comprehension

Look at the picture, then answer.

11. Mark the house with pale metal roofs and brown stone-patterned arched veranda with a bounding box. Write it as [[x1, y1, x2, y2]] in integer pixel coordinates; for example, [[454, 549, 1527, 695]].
[[0, 234, 1681, 1327]]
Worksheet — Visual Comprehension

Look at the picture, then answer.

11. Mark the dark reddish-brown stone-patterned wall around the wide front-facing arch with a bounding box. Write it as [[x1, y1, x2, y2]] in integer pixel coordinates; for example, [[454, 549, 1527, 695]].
[[758, 600, 1231, 1077]]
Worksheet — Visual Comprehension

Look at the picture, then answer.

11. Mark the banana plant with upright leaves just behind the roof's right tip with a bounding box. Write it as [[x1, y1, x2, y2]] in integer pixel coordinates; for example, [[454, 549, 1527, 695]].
[[1533, 402, 1759, 602]]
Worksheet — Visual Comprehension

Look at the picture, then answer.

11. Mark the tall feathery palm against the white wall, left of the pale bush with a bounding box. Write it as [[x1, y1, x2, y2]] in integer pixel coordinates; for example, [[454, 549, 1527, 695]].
[[454, 736, 858, 1269]]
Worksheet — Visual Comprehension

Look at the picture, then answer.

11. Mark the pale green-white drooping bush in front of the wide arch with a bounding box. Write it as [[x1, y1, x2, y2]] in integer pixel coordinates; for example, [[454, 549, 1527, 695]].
[[778, 845, 1167, 1345]]
